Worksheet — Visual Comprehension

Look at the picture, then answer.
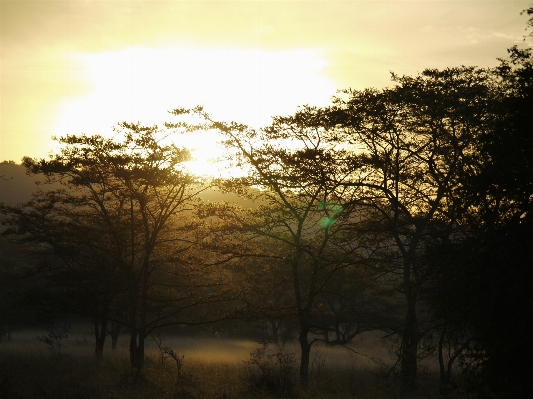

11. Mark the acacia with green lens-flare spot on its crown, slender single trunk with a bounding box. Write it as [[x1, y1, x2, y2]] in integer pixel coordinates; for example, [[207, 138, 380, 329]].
[[169, 108, 380, 388]]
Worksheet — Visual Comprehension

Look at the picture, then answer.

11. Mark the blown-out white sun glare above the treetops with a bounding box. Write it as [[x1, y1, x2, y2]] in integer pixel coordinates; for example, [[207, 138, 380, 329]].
[[54, 47, 335, 175]]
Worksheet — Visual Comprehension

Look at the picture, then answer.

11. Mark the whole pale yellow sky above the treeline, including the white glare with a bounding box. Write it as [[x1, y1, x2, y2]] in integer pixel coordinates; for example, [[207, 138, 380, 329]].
[[0, 0, 533, 170]]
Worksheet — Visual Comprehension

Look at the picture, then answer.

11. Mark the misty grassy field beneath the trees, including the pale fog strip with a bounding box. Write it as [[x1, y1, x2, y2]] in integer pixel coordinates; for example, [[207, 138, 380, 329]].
[[0, 331, 462, 399]]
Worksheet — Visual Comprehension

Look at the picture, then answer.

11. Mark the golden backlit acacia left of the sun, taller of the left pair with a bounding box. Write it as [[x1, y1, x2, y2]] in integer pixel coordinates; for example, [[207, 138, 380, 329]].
[[14, 123, 208, 370]]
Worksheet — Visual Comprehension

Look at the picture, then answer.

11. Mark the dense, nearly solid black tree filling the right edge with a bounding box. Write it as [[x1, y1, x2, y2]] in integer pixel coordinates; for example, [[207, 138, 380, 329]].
[[424, 47, 533, 397]]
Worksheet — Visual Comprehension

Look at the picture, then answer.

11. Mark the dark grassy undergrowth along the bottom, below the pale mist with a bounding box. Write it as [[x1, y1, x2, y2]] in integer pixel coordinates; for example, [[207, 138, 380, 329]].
[[0, 343, 466, 399]]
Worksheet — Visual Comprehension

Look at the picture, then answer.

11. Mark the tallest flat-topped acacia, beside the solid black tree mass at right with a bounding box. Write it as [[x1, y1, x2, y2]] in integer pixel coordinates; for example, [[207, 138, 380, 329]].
[[329, 67, 492, 390]]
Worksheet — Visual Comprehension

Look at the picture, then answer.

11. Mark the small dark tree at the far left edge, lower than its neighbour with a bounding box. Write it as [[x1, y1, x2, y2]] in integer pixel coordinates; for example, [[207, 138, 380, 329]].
[[0, 189, 124, 360]]
